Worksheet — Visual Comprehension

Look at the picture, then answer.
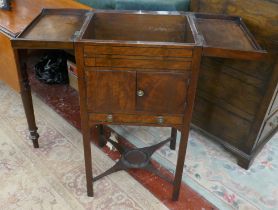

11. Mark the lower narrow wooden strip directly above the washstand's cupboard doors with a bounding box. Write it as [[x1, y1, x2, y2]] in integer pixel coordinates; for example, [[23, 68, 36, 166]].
[[84, 55, 191, 70]]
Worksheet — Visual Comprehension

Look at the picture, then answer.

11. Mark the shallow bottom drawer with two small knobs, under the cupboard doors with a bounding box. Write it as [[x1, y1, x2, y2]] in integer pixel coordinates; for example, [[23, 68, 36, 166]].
[[89, 114, 183, 126]]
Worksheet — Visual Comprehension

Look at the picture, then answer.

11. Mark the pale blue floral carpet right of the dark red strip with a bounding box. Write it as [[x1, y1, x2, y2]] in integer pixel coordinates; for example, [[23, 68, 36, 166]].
[[111, 126, 278, 210]]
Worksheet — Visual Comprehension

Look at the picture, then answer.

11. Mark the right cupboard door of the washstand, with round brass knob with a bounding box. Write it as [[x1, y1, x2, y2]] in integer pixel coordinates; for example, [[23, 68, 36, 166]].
[[136, 72, 190, 114]]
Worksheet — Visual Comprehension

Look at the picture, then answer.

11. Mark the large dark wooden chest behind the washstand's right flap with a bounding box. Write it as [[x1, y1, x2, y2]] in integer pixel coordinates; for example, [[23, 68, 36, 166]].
[[191, 0, 278, 168]]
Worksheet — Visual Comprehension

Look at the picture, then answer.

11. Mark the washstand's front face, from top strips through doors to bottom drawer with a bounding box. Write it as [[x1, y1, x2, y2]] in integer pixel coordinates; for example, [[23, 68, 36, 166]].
[[80, 43, 193, 126]]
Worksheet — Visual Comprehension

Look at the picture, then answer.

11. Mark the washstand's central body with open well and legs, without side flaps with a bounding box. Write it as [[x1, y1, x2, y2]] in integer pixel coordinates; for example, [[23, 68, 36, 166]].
[[72, 11, 201, 200]]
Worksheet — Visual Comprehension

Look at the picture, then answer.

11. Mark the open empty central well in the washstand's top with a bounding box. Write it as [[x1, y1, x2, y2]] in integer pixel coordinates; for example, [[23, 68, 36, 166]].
[[81, 11, 195, 44]]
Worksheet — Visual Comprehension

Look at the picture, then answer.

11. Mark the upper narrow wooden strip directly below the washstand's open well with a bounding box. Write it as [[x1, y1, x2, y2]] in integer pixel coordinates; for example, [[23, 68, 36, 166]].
[[84, 45, 192, 57]]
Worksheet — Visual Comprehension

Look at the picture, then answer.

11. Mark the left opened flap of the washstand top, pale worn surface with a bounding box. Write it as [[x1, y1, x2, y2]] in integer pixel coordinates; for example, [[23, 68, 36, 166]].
[[12, 9, 89, 48]]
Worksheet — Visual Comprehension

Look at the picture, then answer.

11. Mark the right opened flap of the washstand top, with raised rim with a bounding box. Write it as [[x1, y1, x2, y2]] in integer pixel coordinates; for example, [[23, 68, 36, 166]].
[[194, 13, 266, 59]]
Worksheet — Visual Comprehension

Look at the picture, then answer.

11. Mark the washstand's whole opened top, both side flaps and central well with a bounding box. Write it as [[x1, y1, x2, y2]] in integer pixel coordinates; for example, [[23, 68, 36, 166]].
[[12, 9, 266, 60]]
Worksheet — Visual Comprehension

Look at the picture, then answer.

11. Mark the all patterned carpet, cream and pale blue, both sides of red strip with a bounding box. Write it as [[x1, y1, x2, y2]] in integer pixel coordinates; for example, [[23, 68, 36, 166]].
[[0, 76, 278, 210]]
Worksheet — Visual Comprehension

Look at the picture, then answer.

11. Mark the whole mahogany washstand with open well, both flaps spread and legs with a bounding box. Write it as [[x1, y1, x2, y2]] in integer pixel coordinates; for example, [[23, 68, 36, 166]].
[[12, 9, 266, 200]]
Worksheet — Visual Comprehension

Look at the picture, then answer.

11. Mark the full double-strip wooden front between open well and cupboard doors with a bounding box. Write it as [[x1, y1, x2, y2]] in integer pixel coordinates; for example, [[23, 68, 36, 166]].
[[84, 45, 193, 70]]
